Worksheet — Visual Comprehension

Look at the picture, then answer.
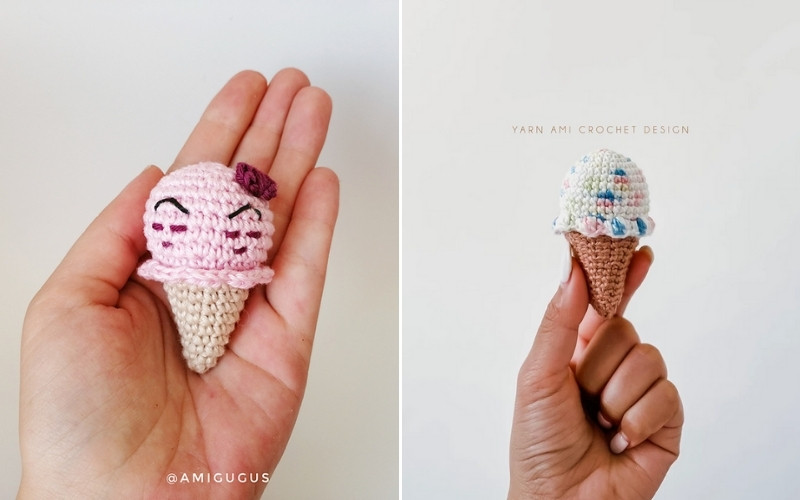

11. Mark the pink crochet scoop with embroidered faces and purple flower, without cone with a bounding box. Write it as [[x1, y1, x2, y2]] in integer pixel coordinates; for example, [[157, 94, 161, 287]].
[[139, 162, 275, 289]]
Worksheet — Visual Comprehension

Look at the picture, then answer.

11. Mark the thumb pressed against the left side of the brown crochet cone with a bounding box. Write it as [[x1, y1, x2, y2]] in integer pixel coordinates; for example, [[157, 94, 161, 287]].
[[526, 257, 589, 376]]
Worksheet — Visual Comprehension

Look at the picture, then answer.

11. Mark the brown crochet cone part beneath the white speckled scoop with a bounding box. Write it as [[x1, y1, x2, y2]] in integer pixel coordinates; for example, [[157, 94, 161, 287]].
[[565, 231, 639, 318]]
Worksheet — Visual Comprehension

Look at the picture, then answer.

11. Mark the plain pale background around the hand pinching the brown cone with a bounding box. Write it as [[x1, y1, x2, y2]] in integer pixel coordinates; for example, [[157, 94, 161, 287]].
[[402, 0, 800, 500]]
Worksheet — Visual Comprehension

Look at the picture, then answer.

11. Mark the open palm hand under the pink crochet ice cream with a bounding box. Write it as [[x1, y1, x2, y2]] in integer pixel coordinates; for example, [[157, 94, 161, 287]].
[[20, 69, 338, 498]]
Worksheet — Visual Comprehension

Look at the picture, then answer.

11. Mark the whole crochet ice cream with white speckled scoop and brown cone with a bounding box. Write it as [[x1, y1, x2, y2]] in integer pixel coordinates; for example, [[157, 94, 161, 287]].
[[553, 149, 655, 317]]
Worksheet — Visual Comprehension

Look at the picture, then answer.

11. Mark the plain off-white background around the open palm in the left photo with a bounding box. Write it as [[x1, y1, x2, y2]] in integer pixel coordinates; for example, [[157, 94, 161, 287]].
[[0, 0, 398, 499]]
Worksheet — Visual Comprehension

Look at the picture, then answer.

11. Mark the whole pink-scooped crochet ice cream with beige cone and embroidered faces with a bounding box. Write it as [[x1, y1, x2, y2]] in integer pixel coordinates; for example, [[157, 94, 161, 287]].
[[139, 162, 276, 373]]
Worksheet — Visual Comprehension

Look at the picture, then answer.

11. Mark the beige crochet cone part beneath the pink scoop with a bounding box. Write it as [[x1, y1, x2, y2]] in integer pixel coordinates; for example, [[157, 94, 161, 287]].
[[164, 283, 250, 373]]
